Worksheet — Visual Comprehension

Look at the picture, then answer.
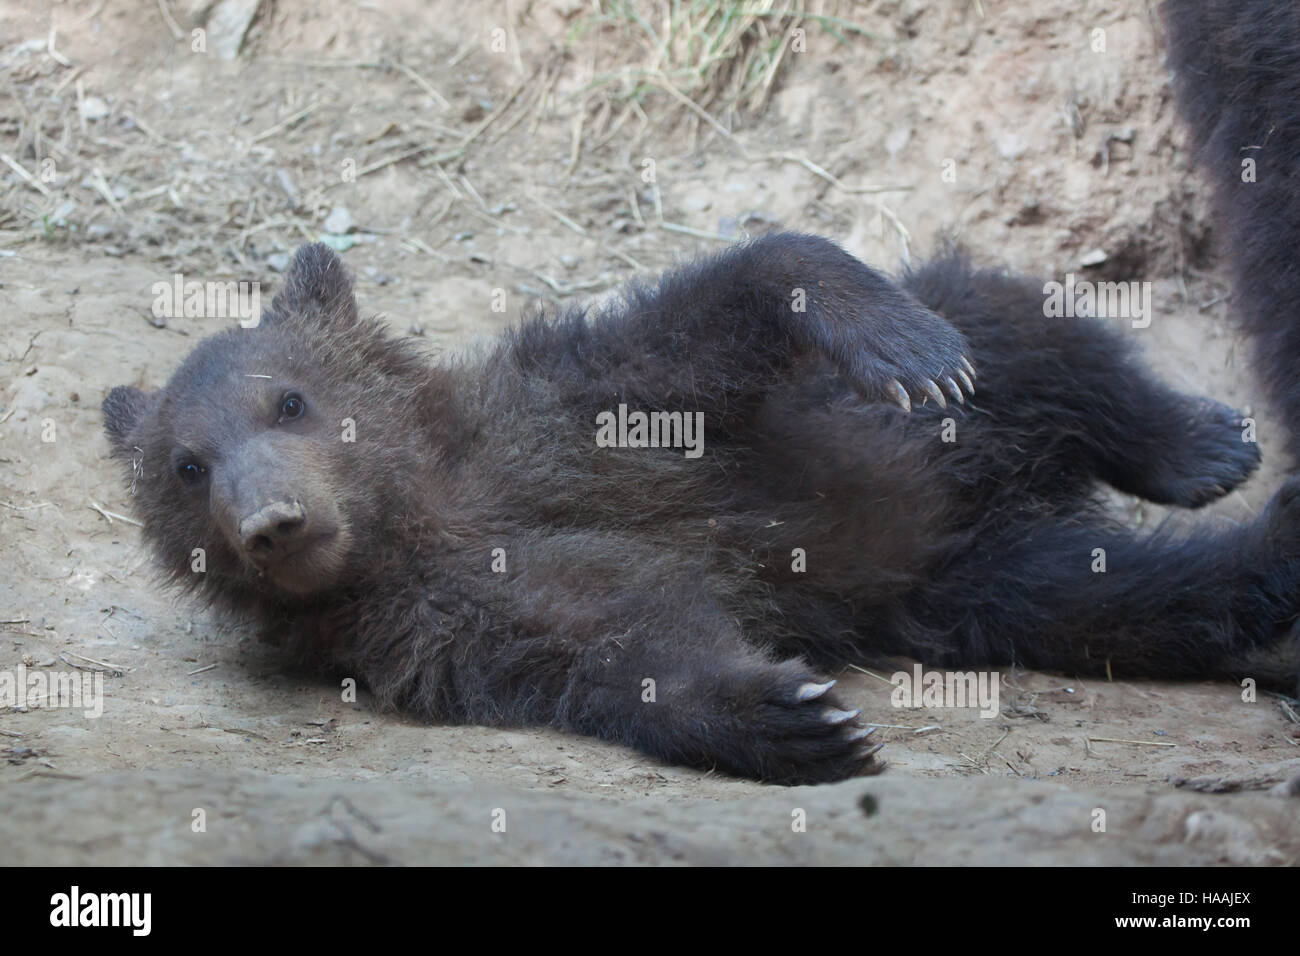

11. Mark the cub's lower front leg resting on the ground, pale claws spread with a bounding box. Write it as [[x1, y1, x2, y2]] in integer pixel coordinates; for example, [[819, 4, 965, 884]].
[[436, 531, 875, 783]]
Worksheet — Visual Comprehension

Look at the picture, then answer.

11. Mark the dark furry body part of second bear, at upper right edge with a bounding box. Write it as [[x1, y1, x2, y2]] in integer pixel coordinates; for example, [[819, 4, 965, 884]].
[[1161, 0, 1300, 464]]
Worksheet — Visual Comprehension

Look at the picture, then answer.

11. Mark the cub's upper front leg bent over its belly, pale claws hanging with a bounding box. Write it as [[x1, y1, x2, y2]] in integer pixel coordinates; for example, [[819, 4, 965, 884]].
[[506, 233, 975, 421]]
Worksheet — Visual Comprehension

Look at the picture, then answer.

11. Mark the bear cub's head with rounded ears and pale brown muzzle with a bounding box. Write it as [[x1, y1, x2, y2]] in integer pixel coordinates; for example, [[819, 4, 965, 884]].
[[103, 245, 428, 604]]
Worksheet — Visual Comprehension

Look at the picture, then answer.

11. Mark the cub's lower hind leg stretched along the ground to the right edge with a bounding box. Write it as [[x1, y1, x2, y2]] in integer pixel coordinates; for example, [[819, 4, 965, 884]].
[[876, 480, 1300, 678]]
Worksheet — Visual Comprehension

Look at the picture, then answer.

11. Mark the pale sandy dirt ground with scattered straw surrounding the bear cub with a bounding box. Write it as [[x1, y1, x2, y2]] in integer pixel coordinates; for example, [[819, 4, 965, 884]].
[[0, 0, 1300, 865]]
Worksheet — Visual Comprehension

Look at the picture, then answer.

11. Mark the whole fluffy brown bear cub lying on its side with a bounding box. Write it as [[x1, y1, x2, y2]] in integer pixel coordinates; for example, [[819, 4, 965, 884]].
[[104, 234, 1300, 783]]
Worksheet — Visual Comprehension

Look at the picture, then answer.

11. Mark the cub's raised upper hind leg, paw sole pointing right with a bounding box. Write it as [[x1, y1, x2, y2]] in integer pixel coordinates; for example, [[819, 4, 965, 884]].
[[906, 259, 1260, 507]]
